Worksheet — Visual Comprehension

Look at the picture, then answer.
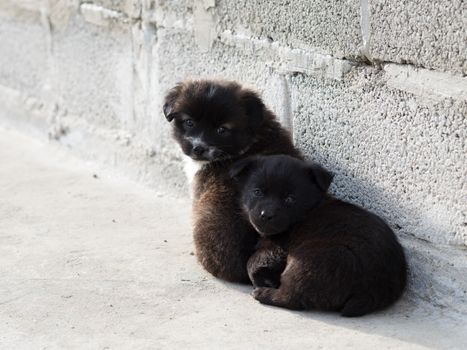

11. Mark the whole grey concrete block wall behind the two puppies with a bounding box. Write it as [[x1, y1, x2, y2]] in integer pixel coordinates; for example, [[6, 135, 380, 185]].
[[0, 0, 467, 313]]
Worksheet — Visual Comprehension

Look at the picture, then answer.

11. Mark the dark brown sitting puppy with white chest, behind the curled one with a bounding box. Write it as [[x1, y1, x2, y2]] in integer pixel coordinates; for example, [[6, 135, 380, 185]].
[[164, 81, 301, 283]]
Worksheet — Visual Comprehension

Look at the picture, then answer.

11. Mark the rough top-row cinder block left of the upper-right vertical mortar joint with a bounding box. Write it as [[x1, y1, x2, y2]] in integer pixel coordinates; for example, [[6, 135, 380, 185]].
[[214, 0, 362, 58]]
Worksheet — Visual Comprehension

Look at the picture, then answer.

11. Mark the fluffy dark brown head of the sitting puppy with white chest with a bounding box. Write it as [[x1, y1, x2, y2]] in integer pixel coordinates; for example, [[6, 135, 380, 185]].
[[164, 81, 265, 162]]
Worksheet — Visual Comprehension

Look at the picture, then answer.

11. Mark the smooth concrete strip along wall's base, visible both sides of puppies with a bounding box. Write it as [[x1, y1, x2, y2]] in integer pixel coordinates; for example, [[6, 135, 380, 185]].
[[0, 88, 467, 314]]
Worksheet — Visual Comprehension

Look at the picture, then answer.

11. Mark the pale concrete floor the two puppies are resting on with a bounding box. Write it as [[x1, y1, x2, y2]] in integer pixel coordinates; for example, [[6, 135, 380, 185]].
[[0, 126, 467, 350]]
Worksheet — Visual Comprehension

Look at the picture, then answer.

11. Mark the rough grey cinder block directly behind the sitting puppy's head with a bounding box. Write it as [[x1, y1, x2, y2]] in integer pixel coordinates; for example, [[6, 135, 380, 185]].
[[153, 29, 300, 127]]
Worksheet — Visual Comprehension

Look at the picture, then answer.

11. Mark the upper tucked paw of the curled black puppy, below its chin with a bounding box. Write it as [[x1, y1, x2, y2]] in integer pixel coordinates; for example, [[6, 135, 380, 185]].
[[247, 238, 287, 288]]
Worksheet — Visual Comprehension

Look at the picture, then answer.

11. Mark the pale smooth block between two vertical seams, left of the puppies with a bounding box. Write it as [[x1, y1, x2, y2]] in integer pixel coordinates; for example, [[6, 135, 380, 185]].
[[51, 16, 133, 130]]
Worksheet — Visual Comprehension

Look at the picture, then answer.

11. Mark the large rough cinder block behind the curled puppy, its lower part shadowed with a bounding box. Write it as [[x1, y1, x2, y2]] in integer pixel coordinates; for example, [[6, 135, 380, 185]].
[[290, 68, 467, 247]]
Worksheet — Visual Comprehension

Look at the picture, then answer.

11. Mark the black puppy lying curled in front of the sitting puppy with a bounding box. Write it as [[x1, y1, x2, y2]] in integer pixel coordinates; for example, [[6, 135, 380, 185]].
[[230, 156, 407, 316]]
